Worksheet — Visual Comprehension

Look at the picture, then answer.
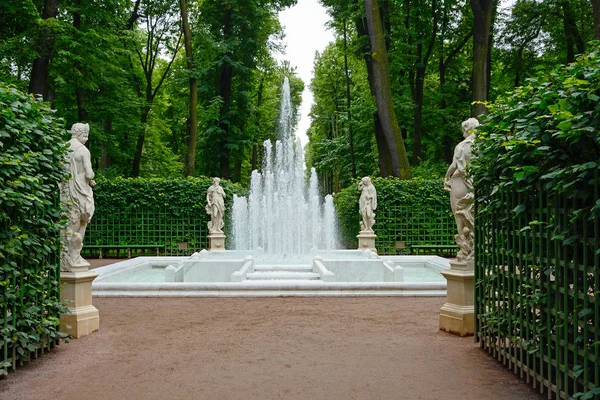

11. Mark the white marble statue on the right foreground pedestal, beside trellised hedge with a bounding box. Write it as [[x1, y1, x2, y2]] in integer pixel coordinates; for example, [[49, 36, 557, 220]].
[[444, 118, 479, 262]]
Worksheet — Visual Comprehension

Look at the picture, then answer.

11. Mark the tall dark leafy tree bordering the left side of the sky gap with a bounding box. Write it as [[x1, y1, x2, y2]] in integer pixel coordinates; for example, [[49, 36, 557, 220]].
[[200, 0, 295, 181]]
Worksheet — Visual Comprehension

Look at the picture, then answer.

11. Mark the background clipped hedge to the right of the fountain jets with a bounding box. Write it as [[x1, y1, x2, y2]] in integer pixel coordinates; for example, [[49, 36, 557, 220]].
[[334, 178, 456, 254]]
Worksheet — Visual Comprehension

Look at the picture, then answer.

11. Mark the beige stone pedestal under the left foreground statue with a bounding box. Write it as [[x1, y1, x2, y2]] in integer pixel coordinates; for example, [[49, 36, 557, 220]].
[[60, 264, 100, 338]]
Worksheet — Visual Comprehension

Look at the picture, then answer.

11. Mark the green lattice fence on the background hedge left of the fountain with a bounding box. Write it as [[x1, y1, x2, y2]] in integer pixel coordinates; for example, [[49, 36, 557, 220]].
[[84, 207, 208, 255]]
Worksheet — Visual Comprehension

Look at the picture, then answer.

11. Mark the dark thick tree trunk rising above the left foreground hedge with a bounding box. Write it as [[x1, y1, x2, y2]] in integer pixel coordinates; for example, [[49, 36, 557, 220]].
[[29, 0, 59, 101]]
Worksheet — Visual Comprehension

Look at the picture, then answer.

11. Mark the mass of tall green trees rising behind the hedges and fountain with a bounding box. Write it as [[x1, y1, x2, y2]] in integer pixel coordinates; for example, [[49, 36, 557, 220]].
[[0, 0, 600, 192]]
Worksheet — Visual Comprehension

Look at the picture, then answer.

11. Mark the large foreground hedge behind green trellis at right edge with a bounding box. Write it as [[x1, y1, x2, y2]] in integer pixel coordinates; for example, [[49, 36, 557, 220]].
[[471, 42, 600, 399]]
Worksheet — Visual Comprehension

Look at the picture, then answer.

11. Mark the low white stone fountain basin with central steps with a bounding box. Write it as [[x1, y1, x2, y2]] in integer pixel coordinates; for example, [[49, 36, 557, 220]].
[[92, 250, 449, 297]]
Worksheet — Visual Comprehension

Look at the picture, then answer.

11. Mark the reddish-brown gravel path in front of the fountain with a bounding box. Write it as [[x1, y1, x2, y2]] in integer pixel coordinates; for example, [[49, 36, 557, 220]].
[[0, 298, 544, 400]]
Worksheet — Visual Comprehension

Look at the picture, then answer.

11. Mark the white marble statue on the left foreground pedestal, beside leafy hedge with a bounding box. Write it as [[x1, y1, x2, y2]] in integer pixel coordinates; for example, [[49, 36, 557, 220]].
[[61, 123, 96, 272]]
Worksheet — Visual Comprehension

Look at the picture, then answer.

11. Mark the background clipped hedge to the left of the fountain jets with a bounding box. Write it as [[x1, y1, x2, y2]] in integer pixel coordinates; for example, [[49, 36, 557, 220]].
[[84, 177, 246, 255]]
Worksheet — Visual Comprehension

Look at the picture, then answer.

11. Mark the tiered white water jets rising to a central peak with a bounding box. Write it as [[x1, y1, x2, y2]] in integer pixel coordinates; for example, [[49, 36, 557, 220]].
[[232, 77, 335, 255]]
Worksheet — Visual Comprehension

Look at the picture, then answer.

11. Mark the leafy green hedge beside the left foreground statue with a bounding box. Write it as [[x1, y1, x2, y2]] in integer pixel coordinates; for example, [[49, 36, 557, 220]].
[[0, 84, 67, 375]]
